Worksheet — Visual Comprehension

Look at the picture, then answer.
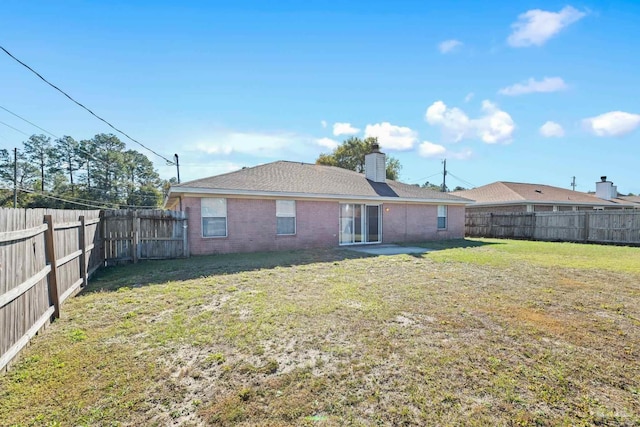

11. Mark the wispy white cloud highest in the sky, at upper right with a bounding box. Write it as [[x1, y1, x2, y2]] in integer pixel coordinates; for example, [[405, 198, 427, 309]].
[[507, 6, 587, 47]]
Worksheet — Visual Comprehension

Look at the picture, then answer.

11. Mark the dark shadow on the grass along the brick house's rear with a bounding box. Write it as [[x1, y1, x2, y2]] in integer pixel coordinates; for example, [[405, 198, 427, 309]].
[[82, 248, 373, 293]]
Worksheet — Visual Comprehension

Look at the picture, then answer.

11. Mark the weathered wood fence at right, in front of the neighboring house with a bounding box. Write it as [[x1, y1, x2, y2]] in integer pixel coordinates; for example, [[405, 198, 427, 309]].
[[465, 210, 640, 245]]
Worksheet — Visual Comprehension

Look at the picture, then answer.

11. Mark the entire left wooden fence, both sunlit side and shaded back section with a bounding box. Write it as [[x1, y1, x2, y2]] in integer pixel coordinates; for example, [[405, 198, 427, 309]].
[[0, 208, 189, 370]]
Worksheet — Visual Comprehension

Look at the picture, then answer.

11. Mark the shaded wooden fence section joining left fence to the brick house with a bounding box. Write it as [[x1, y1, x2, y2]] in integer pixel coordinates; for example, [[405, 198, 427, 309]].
[[102, 209, 189, 265]]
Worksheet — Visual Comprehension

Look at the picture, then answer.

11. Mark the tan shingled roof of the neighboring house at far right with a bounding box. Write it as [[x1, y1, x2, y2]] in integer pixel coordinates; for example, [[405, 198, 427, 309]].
[[453, 181, 633, 207]]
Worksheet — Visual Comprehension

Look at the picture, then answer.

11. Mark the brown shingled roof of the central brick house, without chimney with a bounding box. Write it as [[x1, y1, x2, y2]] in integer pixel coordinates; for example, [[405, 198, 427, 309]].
[[165, 161, 471, 206]]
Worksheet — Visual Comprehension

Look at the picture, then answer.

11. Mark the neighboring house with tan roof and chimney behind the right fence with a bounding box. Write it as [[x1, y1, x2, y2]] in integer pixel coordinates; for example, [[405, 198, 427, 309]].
[[452, 176, 638, 213]]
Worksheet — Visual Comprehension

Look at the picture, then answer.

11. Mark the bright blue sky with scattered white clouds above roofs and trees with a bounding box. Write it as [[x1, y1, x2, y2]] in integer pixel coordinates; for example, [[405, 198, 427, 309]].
[[0, 0, 640, 194]]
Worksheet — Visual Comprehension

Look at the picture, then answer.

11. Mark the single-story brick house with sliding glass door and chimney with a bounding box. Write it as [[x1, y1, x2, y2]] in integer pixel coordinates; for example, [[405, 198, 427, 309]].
[[165, 147, 469, 254]]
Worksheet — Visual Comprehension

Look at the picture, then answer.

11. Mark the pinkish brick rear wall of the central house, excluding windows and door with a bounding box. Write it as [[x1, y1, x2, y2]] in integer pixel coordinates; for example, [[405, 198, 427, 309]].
[[182, 197, 464, 255]]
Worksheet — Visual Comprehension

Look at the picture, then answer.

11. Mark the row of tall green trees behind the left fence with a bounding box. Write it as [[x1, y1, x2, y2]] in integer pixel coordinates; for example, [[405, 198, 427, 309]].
[[0, 133, 175, 209]]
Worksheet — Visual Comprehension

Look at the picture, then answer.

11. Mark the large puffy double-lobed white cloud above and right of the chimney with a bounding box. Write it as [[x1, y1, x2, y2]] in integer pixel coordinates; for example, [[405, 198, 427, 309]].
[[425, 100, 515, 144]]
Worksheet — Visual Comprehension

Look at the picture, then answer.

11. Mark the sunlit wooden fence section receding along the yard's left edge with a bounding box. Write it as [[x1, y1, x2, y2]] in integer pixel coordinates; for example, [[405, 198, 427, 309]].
[[0, 209, 103, 370]]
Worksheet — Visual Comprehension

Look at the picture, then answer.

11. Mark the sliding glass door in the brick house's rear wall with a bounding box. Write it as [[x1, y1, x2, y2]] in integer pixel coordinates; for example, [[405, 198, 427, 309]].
[[340, 203, 382, 245]]
